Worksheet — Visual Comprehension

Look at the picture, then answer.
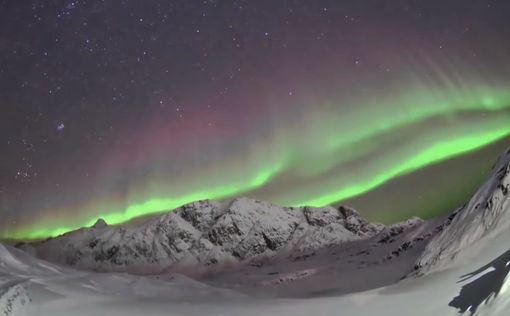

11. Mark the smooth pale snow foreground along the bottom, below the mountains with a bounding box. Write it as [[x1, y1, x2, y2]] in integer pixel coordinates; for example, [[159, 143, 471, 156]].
[[0, 226, 510, 316]]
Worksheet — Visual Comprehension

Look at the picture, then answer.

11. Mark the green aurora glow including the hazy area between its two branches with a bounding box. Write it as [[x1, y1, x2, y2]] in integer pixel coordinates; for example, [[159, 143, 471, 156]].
[[0, 81, 510, 240]]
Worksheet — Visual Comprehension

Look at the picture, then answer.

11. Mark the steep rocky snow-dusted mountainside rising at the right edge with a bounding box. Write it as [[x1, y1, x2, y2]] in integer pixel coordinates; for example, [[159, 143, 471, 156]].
[[417, 149, 510, 273]]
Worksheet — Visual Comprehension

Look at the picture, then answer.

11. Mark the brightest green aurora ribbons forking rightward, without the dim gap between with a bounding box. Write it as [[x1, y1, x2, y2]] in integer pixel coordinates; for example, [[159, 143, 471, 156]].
[[1, 84, 510, 240]]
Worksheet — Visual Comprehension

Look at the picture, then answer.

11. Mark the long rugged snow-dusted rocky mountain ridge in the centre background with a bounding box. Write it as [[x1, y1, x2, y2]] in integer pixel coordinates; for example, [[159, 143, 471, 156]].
[[21, 198, 385, 272]]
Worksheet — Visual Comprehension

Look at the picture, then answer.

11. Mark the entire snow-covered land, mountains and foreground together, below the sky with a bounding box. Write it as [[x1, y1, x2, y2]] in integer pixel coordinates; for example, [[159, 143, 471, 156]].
[[0, 150, 510, 316]]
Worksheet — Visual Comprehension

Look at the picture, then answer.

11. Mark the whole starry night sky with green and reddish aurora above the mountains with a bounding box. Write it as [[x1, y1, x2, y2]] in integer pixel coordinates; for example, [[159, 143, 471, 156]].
[[0, 0, 510, 238]]
